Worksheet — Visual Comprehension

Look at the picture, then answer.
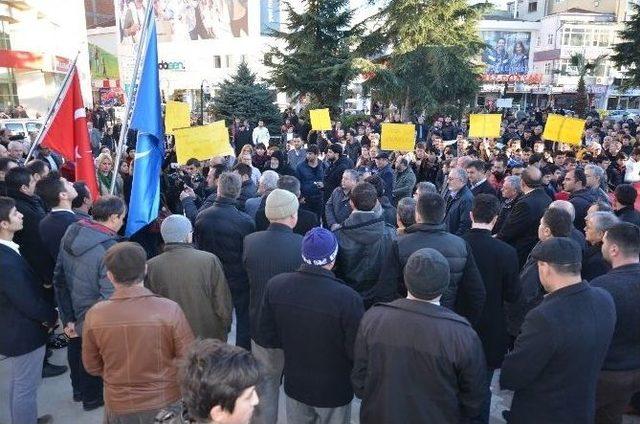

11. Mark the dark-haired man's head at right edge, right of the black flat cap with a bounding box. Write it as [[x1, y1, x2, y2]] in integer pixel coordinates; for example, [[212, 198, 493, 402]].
[[602, 222, 640, 268]]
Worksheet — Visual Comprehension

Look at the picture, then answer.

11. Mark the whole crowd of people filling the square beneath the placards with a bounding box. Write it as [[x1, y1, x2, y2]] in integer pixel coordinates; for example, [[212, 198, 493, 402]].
[[0, 105, 640, 424]]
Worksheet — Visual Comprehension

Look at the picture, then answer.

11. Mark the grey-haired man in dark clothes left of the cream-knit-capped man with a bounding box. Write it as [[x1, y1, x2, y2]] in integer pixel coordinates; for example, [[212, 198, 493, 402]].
[[194, 172, 255, 350]]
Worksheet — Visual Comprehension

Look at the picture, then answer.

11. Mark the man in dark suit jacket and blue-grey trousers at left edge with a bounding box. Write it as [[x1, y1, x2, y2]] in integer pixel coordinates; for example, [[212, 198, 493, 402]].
[[0, 197, 58, 424]]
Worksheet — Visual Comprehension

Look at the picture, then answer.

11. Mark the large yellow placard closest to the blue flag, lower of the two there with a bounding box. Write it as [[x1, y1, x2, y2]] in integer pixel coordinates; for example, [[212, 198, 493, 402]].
[[174, 121, 234, 165]]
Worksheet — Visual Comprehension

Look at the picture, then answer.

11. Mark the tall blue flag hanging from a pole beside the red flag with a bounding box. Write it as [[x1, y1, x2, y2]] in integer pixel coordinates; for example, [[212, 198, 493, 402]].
[[125, 17, 164, 236]]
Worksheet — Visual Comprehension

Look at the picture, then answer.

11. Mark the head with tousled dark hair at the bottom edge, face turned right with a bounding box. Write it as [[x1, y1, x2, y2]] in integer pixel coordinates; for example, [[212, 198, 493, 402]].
[[180, 339, 260, 424]]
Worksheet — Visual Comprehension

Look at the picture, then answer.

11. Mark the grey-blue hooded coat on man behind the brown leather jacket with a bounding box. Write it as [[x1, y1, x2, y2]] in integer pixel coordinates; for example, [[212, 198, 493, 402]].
[[53, 221, 118, 334]]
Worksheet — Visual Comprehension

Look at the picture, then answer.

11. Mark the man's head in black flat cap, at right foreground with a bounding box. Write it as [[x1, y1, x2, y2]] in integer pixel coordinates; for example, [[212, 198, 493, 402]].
[[531, 237, 582, 293]]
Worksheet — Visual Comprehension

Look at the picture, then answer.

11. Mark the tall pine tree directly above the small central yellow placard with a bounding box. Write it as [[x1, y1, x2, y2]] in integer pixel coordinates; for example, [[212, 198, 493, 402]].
[[265, 0, 357, 108]]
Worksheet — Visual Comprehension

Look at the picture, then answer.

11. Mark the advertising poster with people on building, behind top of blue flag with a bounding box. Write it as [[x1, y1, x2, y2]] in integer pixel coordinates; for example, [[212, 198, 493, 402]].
[[115, 0, 249, 45]]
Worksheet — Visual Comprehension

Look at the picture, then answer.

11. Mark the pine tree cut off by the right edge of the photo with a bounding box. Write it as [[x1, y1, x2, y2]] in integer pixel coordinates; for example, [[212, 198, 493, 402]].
[[611, 4, 640, 88]]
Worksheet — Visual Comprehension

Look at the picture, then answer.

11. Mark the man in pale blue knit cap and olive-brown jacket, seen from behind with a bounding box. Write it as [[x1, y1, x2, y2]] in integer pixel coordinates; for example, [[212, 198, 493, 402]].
[[144, 215, 233, 341]]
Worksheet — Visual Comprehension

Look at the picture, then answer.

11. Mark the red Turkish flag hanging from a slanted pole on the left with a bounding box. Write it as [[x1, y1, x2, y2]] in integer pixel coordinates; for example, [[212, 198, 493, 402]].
[[41, 67, 100, 200]]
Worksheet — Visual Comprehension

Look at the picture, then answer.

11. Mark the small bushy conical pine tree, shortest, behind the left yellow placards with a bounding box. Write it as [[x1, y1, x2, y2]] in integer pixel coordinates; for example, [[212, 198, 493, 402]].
[[211, 62, 281, 132]]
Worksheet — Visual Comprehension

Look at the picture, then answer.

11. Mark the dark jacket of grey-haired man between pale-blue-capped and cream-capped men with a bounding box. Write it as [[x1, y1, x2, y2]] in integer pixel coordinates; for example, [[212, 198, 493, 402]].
[[193, 197, 256, 291]]
